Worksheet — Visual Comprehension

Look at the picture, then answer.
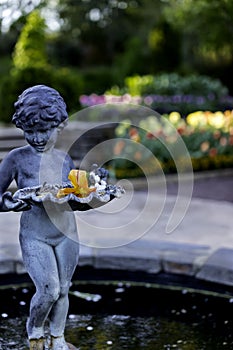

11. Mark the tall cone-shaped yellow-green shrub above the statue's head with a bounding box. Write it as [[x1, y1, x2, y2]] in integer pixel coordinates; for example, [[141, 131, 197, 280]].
[[13, 10, 48, 69]]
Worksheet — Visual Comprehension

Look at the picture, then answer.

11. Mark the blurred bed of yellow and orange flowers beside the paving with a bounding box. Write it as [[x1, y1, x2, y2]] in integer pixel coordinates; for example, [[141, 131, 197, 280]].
[[109, 110, 233, 178]]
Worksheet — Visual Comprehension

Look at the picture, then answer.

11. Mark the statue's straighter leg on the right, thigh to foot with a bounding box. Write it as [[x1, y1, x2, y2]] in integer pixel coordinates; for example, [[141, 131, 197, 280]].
[[49, 237, 79, 350]]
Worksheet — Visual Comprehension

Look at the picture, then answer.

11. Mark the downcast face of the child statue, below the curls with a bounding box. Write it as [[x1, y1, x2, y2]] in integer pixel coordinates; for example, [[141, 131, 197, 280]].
[[24, 125, 58, 152]]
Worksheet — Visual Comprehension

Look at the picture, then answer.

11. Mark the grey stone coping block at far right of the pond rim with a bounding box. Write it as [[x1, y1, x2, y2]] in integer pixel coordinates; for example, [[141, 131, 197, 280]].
[[196, 248, 233, 286]]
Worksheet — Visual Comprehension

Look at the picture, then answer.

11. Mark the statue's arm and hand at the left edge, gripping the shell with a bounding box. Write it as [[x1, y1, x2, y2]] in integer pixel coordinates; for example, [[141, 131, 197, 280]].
[[0, 152, 30, 212]]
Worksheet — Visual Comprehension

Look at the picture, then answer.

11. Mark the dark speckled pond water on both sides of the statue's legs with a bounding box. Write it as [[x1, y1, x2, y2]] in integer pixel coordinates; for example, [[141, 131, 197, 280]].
[[0, 283, 233, 350]]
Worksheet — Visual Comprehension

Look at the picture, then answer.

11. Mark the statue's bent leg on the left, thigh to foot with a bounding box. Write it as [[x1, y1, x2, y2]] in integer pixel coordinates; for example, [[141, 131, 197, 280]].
[[21, 239, 60, 339]]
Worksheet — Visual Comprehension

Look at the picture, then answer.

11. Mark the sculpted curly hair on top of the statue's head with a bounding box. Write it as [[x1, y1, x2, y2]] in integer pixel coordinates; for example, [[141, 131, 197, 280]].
[[12, 85, 68, 130]]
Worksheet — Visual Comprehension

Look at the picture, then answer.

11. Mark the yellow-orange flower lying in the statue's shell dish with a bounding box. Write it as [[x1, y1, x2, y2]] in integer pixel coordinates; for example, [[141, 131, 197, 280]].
[[57, 169, 96, 198]]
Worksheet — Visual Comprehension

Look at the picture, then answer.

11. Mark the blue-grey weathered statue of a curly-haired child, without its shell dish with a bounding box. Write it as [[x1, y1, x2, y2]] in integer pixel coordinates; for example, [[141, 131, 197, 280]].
[[0, 85, 79, 350]]
